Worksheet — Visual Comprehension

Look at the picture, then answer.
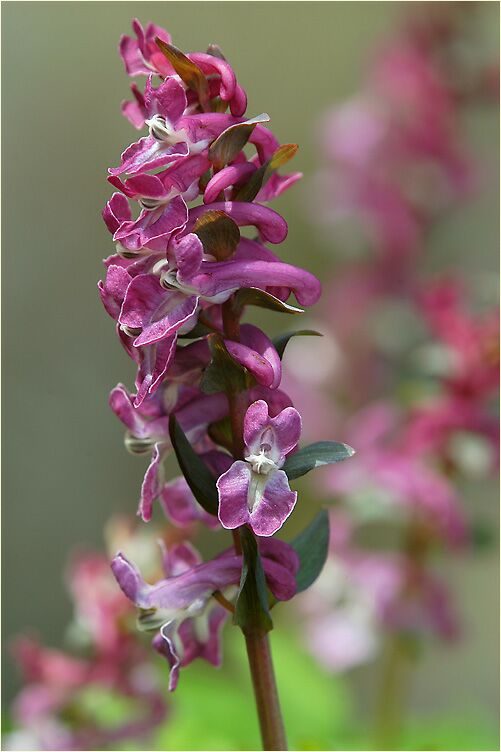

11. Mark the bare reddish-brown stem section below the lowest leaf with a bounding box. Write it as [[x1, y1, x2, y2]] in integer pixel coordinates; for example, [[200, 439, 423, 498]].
[[245, 632, 287, 750]]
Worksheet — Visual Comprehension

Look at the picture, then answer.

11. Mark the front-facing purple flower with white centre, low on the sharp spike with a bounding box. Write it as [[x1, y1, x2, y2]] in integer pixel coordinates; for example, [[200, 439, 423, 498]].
[[217, 400, 301, 536]]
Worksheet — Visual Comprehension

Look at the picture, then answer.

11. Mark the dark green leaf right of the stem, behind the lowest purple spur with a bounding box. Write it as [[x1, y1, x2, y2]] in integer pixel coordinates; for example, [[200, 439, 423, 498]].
[[290, 509, 329, 593]]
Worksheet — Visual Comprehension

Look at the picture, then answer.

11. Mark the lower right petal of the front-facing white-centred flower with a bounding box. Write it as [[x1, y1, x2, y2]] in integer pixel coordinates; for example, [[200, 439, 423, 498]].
[[249, 470, 297, 537]]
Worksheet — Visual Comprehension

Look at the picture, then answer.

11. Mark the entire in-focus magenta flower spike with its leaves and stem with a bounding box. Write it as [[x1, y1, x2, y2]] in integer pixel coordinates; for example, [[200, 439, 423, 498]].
[[99, 20, 353, 749]]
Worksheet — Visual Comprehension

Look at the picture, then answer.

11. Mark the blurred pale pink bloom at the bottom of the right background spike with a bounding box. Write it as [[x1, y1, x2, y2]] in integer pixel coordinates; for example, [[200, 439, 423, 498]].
[[298, 512, 458, 672]]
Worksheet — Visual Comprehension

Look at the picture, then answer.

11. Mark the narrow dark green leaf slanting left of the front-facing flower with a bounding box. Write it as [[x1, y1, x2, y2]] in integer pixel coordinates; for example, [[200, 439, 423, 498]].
[[169, 414, 218, 515]]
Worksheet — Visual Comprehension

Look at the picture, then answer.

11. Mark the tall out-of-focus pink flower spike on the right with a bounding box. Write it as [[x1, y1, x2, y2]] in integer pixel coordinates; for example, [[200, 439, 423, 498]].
[[286, 7, 499, 670]]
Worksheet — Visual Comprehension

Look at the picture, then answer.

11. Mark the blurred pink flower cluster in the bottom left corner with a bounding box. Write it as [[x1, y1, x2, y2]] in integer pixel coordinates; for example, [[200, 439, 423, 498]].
[[5, 520, 168, 750]]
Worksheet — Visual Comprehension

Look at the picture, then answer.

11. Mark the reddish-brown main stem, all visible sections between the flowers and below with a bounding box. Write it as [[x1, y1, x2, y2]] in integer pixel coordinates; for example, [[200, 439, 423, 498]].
[[222, 298, 287, 750]]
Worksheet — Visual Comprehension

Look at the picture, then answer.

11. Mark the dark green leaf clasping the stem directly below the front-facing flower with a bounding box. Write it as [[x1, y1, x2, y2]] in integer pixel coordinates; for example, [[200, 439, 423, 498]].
[[233, 527, 273, 632]]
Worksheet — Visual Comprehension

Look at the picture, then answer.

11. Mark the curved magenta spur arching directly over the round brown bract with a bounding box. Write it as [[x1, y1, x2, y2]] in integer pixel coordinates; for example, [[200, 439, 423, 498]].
[[188, 201, 287, 243]]
